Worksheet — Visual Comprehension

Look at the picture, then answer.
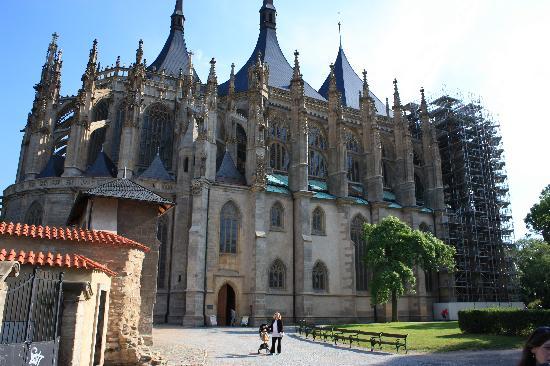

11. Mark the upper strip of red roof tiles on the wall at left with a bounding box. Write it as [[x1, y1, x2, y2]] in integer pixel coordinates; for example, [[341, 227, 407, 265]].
[[0, 222, 150, 253]]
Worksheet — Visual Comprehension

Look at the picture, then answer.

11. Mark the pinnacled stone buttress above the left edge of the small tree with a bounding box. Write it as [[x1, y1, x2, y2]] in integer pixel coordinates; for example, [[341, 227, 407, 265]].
[[359, 70, 384, 202]]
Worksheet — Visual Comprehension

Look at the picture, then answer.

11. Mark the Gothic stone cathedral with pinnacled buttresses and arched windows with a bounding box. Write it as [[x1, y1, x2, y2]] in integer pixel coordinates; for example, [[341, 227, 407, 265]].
[[3, 0, 451, 326]]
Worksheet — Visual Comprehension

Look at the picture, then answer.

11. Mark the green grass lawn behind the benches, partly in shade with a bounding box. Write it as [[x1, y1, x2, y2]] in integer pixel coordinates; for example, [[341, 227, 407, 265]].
[[339, 321, 525, 352]]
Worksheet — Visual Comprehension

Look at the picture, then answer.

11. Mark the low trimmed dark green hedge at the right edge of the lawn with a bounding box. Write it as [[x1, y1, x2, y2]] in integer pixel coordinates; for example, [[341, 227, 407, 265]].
[[458, 308, 550, 336]]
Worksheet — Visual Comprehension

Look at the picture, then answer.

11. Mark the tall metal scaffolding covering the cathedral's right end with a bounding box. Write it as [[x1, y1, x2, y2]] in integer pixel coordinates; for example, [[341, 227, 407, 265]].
[[430, 96, 518, 302]]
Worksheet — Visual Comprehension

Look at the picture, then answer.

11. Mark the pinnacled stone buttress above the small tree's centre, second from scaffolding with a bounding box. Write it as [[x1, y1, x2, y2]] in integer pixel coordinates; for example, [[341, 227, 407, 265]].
[[393, 79, 416, 207]]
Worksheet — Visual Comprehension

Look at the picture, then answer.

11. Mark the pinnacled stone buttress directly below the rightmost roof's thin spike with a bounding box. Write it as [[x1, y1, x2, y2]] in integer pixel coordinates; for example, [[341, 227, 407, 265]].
[[328, 64, 348, 197]]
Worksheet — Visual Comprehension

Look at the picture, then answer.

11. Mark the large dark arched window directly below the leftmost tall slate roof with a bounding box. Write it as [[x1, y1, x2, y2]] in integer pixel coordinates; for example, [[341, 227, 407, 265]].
[[139, 103, 174, 170]]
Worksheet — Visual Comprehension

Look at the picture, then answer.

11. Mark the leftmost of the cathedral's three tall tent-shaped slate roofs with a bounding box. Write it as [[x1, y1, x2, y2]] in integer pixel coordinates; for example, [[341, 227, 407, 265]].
[[147, 0, 200, 81]]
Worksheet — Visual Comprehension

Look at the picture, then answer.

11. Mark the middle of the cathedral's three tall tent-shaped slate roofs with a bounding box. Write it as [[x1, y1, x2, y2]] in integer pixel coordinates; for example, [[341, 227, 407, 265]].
[[218, 0, 325, 100]]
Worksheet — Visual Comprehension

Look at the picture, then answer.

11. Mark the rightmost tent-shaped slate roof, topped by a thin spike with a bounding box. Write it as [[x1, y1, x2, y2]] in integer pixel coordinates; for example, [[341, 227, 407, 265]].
[[319, 45, 386, 116]]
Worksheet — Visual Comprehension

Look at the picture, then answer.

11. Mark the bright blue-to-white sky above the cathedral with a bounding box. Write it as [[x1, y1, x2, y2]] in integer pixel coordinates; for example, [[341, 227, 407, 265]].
[[0, 0, 550, 238]]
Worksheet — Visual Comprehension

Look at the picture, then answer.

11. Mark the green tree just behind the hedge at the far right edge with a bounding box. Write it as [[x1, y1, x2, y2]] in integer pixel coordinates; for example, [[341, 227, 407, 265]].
[[517, 238, 550, 309]]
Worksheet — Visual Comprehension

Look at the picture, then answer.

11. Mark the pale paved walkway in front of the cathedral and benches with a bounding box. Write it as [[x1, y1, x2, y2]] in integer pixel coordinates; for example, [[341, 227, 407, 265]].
[[153, 327, 519, 366]]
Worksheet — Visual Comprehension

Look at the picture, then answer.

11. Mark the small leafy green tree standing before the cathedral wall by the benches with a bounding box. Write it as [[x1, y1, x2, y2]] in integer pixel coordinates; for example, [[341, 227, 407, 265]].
[[363, 216, 456, 322]]
